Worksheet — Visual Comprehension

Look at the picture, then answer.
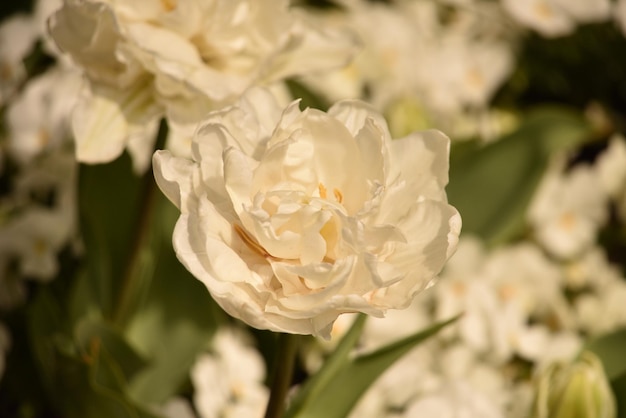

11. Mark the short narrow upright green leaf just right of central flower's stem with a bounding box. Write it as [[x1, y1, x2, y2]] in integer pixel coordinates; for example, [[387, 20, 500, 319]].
[[285, 314, 367, 418]]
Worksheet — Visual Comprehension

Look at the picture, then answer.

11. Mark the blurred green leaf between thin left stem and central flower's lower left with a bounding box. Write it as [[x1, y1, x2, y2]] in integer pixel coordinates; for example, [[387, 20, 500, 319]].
[[125, 193, 223, 404]]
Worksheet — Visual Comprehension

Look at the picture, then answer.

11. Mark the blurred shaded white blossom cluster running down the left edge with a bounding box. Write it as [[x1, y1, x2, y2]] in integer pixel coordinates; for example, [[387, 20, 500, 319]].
[[0, 0, 82, 378]]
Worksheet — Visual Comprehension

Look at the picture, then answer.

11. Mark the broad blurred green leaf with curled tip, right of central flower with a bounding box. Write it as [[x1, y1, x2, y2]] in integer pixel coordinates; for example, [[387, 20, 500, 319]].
[[447, 108, 591, 244]]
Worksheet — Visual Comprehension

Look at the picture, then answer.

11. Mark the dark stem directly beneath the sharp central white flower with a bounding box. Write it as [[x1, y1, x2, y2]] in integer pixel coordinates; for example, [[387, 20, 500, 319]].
[[265, 333, 298, 418]]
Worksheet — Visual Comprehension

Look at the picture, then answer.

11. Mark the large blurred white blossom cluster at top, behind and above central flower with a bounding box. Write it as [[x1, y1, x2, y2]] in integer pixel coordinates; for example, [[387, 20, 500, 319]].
[[304, 1, 513, 126]]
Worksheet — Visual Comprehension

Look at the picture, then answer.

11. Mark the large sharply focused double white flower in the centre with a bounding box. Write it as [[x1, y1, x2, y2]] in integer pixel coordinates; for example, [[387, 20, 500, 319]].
[[154, 90, 461, 337]]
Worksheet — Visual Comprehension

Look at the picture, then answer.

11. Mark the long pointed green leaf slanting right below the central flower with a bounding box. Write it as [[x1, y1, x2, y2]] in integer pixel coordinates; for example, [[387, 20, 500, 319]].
[[286, 317, 458, 418]]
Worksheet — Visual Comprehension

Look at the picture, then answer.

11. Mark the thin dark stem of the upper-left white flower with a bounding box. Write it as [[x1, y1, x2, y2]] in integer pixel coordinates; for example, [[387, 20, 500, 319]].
[[113, 121, 167, 327]]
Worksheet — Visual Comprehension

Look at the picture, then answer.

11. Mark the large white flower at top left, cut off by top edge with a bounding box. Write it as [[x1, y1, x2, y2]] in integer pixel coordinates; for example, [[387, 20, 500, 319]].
[[50, 0, 355, 169]]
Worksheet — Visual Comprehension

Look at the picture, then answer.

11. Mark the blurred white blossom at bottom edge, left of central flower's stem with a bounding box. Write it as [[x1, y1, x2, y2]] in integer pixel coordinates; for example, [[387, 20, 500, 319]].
[[191, 328, 269, 418]]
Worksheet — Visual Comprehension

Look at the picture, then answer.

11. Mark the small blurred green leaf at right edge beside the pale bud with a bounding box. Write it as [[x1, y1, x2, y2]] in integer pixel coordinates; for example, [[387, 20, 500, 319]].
[[585, 328, 626, 380]]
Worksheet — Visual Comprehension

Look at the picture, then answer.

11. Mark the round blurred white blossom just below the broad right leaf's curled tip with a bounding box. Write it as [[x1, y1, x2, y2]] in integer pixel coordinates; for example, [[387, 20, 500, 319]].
[[528, 165, 608, 259]]
